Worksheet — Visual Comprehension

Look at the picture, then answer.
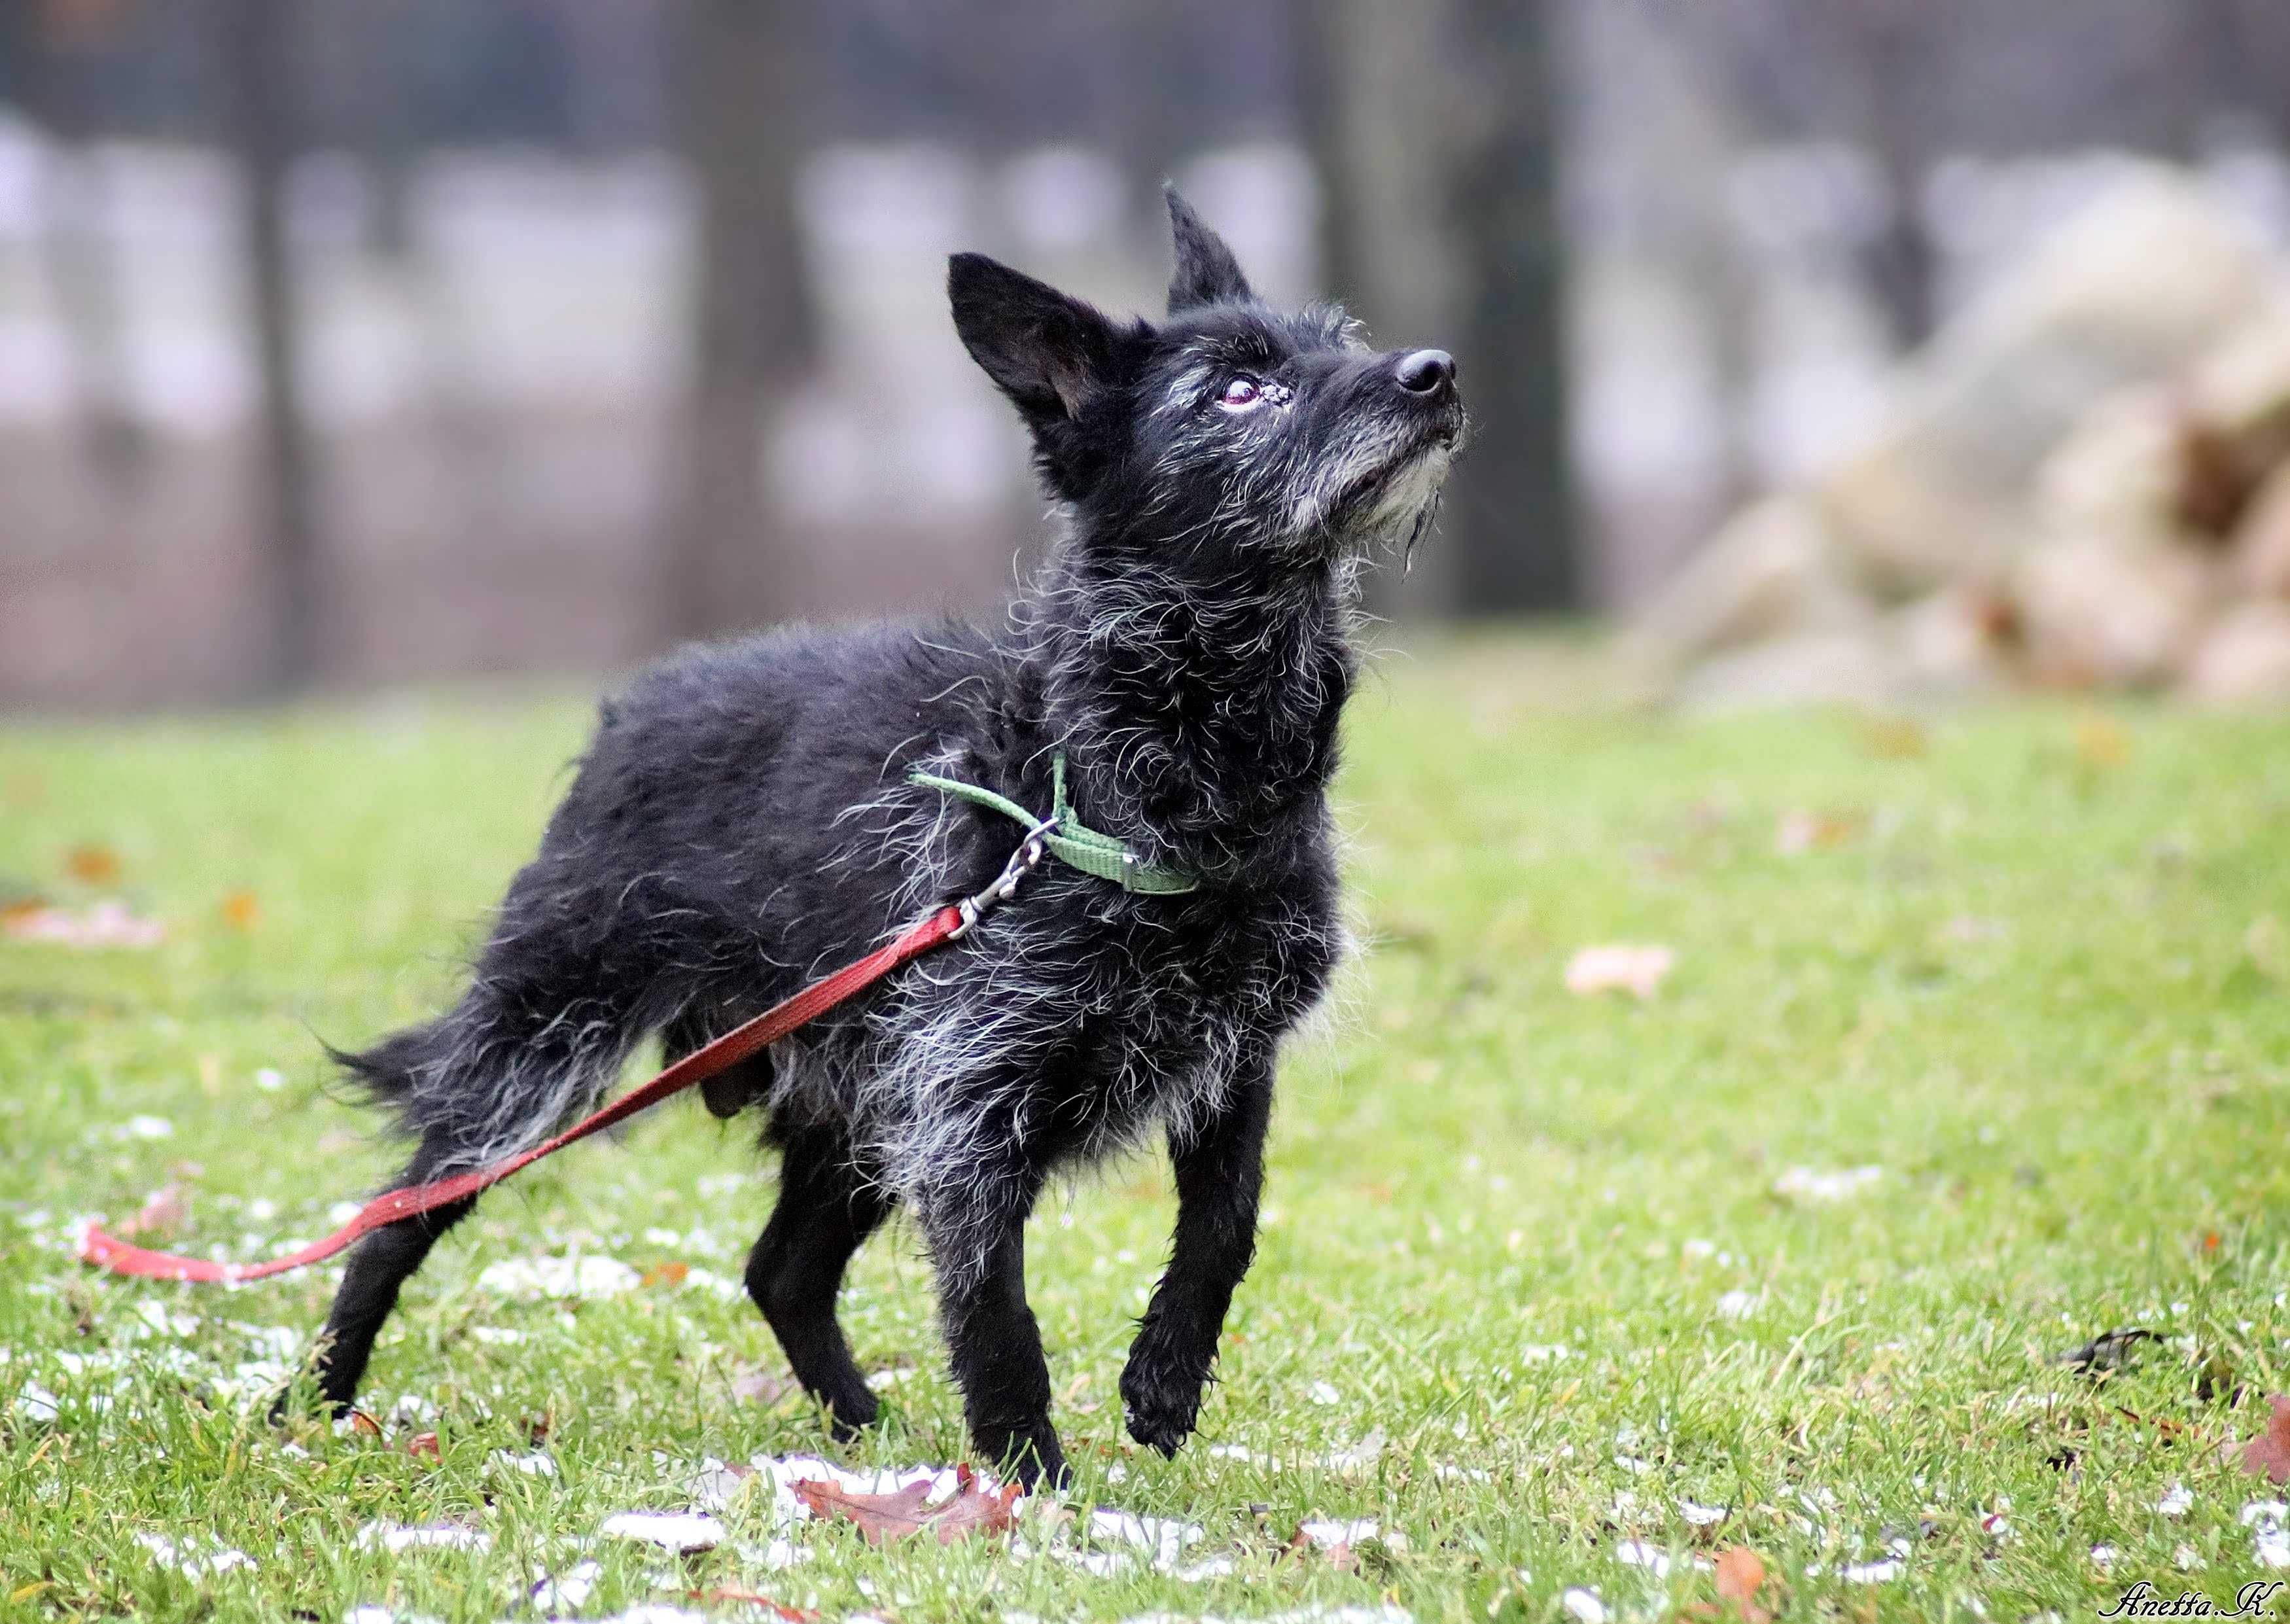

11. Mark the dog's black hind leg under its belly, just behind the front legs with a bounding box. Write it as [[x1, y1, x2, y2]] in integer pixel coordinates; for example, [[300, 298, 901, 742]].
[[747, 1127, 891, 1443]]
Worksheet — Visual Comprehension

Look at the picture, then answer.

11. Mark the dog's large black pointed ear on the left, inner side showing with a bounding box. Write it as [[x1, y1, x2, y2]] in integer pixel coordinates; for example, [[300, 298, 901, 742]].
[[946, 255, 1143, 433]]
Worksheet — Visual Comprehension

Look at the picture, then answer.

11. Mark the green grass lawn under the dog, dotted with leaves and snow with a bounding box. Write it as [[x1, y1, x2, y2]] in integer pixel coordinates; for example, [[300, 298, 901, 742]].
[[0, 644, 2290, 1624]]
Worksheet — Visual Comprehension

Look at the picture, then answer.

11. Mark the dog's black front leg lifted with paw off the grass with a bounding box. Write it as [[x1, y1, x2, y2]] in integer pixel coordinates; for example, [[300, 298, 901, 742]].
[[1122, 1049, 1273, 1455]]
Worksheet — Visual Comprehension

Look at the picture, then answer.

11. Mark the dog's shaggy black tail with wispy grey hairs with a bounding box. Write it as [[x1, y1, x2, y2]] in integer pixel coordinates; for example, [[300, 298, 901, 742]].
[[332, 980, 639, 1177]]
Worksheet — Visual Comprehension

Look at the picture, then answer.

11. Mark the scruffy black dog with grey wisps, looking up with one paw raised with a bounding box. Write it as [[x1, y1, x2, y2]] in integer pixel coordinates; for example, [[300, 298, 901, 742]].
[[304, 192, 1464, 1482]]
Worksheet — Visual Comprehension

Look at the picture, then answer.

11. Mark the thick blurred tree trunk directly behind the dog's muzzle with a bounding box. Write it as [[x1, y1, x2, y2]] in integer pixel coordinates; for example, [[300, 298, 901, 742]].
[[1296, 0, 1580, 614]]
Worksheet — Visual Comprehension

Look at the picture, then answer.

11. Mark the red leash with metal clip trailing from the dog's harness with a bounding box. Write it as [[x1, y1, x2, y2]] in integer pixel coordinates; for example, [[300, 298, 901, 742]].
[[80, 898, 971, 1285]]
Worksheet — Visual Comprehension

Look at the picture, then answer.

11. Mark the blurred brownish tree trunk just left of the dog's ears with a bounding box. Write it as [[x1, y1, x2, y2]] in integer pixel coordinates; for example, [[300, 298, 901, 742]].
[[662, 0, 818, 637]]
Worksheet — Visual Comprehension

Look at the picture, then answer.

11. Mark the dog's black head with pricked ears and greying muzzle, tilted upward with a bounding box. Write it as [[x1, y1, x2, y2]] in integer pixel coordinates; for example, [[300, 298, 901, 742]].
[[948, 190, 1464, 561]]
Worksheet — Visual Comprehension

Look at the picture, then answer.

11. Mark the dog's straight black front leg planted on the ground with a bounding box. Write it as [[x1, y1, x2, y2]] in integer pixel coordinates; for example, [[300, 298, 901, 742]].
[[919, 1159, 1070, 1489]]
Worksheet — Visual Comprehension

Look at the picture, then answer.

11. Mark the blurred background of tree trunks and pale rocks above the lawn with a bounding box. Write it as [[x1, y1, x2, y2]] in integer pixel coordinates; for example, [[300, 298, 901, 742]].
[[0, 0, 2290, 710]]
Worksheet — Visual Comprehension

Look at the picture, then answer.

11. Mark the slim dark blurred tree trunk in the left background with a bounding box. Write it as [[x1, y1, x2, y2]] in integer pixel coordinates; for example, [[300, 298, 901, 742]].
[[213, 0, 323, 694]]
